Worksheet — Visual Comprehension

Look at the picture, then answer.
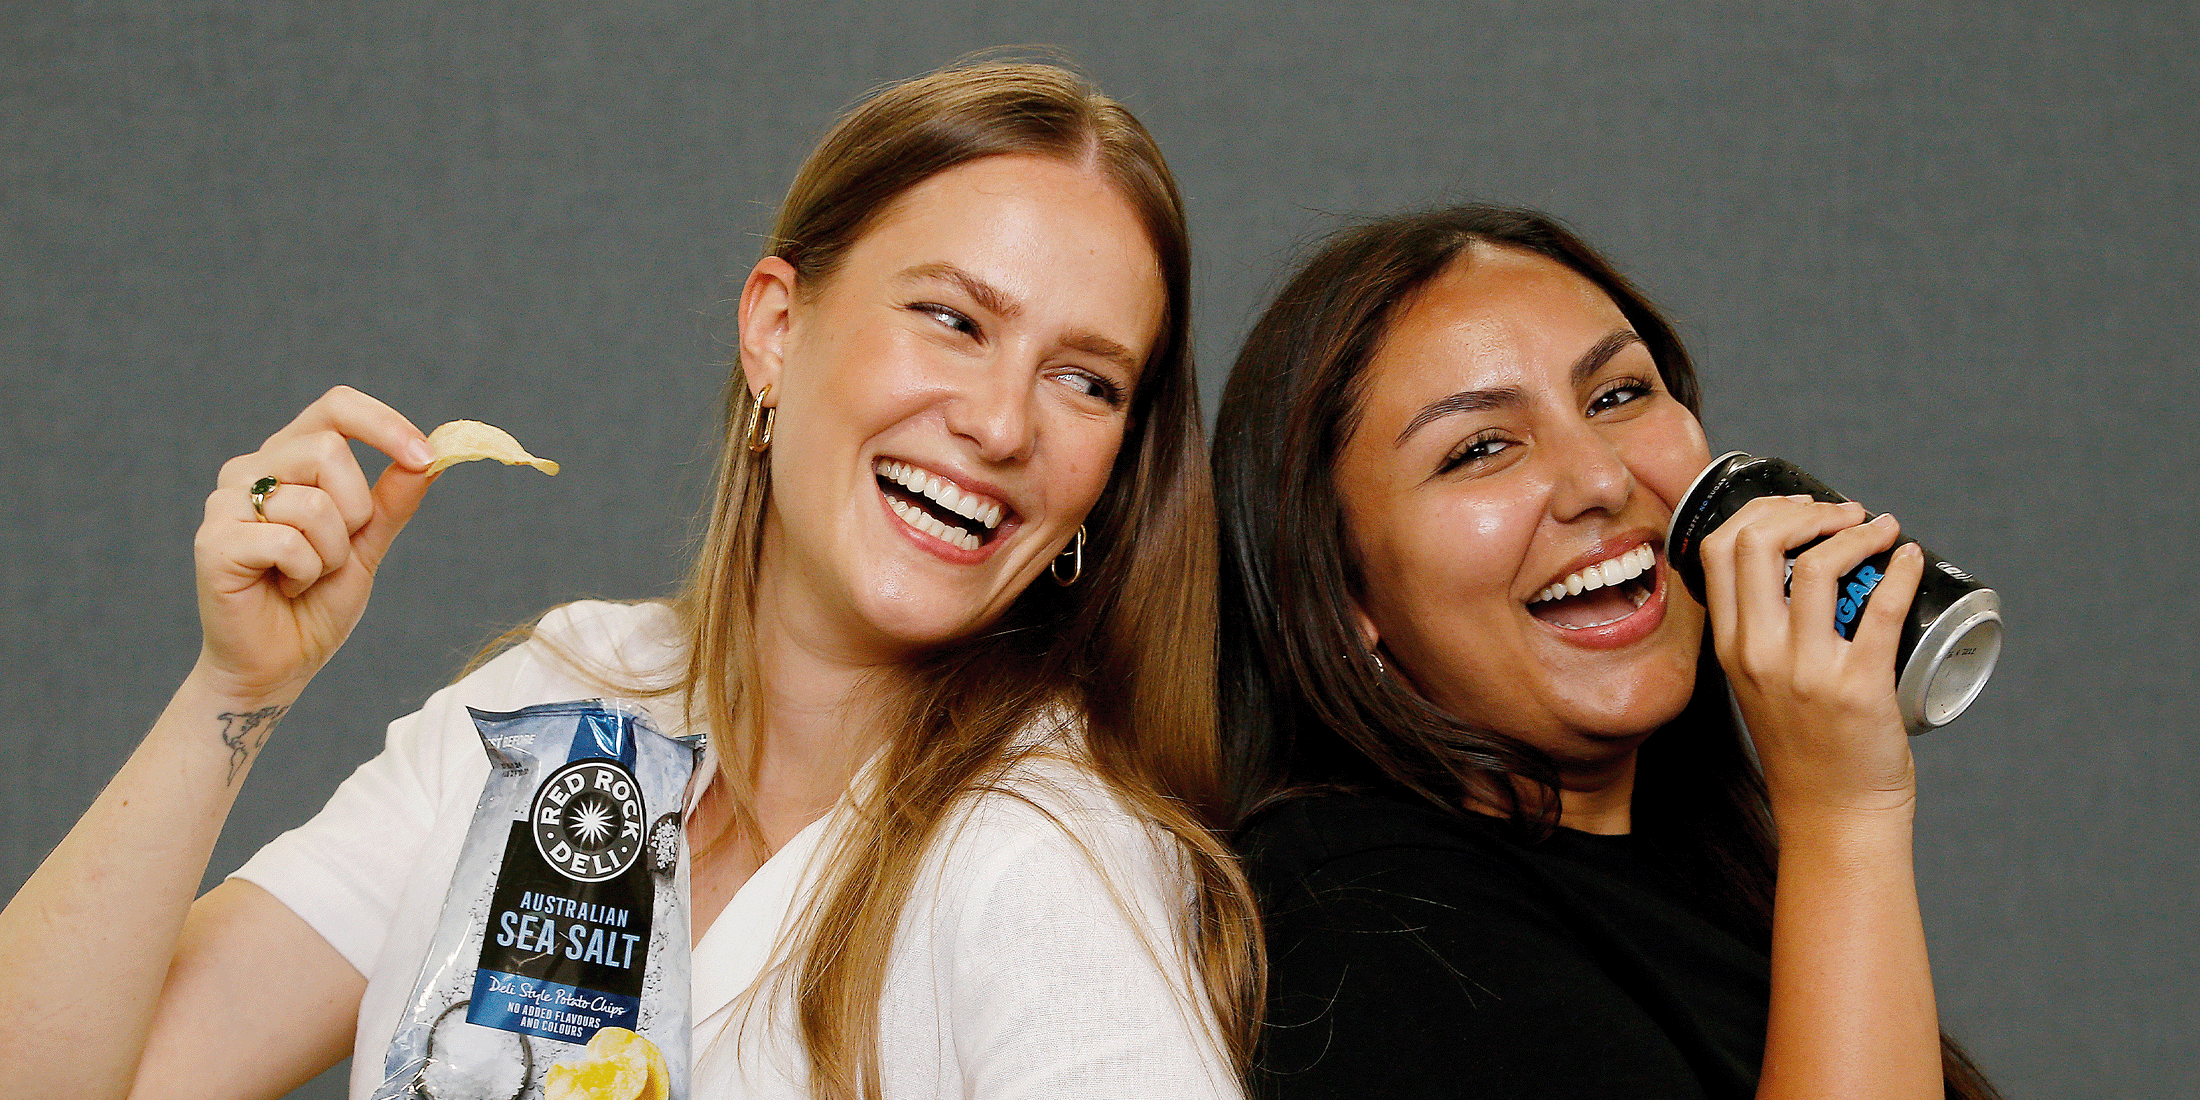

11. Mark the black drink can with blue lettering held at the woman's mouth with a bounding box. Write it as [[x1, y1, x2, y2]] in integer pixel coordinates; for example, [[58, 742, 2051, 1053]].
[[1665, 451, 2002, 735]]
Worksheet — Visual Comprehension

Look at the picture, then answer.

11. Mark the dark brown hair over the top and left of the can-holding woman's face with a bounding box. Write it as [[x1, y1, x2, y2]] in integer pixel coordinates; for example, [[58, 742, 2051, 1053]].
[[1214, 207, 1698, 818]]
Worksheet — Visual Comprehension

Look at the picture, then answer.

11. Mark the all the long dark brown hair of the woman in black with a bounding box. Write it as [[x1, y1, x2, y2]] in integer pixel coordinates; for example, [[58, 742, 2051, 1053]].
[[1214, 205, 1998, 1100]]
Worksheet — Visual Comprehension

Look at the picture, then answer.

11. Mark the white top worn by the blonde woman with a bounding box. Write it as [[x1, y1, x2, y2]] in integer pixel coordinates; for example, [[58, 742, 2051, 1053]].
[[238, 603, 1236, 1100]]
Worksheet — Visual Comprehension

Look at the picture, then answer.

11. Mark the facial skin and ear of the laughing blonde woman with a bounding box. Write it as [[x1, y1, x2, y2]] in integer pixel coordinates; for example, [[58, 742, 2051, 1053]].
[[744, 156, 1166, 664]]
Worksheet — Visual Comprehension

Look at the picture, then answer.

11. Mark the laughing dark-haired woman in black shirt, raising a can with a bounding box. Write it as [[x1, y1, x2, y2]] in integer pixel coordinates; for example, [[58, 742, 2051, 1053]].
[[1214, 207, 1991, 1098]]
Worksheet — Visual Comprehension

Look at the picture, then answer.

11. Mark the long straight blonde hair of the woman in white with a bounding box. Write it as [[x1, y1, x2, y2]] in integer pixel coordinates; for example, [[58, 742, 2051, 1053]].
[[662, 62, 1261, 1098]]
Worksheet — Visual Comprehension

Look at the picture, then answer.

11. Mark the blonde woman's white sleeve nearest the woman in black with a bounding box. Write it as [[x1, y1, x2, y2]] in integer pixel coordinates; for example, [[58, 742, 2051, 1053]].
[[919, 774, 1239, 1100]]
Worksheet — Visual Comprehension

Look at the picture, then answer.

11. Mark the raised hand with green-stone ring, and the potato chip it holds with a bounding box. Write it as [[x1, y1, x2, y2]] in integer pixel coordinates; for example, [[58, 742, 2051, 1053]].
[[191, 385, 557, 702]]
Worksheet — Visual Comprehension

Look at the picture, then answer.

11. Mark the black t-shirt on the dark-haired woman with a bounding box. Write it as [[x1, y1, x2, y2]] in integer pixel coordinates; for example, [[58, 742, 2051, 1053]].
[[1241, 794, 1771, 1100]]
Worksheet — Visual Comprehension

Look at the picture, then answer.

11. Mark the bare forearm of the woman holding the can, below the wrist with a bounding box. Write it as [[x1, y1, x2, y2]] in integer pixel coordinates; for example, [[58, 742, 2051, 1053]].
[[1758, 805, 1940, 1100]]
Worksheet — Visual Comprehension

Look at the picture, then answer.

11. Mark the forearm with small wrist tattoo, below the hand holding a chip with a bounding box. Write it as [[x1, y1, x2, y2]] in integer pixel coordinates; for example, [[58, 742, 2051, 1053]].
[[0, 675, 295, 1098]]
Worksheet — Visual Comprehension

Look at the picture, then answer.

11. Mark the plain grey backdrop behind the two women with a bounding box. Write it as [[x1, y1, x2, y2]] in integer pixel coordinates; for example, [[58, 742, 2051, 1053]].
[[0, 0, 2200, 1098]]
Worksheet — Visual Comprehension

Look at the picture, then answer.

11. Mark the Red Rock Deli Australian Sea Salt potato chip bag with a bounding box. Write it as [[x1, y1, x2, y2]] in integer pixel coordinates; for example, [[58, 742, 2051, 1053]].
[[374, 700, 697, 1100]]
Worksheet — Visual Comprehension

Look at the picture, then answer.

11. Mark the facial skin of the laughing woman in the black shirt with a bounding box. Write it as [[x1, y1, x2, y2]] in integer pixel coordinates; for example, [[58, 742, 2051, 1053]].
[[1335, 246, 1709, 772]]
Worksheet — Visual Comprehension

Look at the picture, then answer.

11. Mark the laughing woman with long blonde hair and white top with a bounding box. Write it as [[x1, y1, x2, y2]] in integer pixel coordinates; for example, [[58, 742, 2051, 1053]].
[[0, 64, 1256, 1098]]
